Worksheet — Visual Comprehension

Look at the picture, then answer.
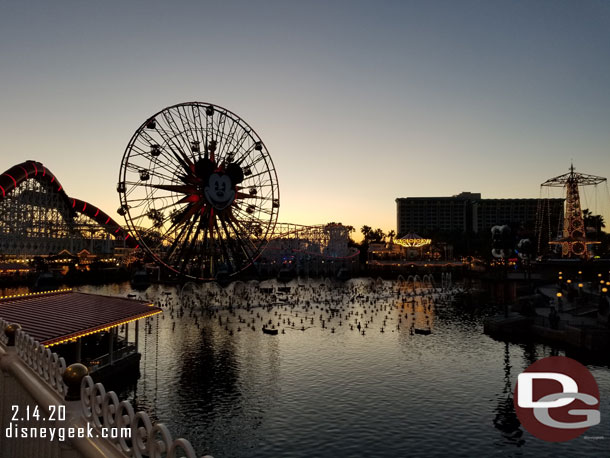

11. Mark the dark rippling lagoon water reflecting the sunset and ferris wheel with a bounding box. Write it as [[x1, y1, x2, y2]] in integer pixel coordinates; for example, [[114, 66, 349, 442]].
[[72, 279, 610, 458]]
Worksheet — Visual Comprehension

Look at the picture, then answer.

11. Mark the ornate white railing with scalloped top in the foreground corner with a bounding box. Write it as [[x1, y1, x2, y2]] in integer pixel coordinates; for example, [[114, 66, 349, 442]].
[[0, 319, 211, 458]]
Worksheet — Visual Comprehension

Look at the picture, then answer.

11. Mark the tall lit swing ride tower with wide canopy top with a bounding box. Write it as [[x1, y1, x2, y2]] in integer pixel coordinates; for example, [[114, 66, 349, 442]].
[[540, 164, 606, 259]]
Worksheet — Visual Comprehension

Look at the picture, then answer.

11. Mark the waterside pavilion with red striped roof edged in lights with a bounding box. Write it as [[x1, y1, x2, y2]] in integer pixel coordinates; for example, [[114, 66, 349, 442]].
[[0, 288, 162, 381]]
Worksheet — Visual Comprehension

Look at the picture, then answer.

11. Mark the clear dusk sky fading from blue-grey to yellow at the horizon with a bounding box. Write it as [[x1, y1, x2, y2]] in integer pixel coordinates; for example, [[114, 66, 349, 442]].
[[0, 0, 610, 240]]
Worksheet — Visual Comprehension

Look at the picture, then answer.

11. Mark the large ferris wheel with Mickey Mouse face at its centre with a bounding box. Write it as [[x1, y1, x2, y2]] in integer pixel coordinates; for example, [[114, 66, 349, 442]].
[[117, 102, 280, 280]]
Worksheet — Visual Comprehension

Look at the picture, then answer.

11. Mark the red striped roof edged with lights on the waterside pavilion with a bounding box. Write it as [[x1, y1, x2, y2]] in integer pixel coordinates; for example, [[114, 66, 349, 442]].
[[0, 292, 162, 346]]
